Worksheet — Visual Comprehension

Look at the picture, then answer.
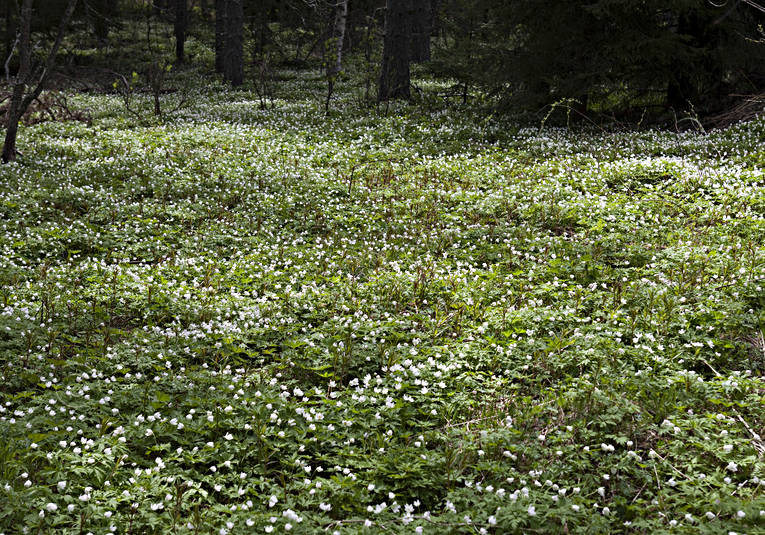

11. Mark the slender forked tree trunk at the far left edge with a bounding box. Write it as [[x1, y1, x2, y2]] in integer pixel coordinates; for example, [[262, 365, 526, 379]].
[[2, 0, 77, 163]]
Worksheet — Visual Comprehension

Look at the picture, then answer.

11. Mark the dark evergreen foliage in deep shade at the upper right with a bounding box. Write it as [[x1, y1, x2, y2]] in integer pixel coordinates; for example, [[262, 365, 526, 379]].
[[435, 0, 765, 117]]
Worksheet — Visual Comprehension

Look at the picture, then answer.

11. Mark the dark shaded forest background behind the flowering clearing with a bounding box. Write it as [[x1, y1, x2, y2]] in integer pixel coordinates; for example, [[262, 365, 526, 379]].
[[0, 0, 765, 151]]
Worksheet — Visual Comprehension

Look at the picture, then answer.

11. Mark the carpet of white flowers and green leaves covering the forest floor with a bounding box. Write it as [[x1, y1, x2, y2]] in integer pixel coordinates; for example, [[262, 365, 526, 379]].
[[0, 73, 765, 535]]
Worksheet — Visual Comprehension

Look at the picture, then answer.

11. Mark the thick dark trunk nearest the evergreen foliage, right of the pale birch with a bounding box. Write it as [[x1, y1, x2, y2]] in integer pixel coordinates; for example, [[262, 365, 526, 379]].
[[377, 0, 412, 101]]
